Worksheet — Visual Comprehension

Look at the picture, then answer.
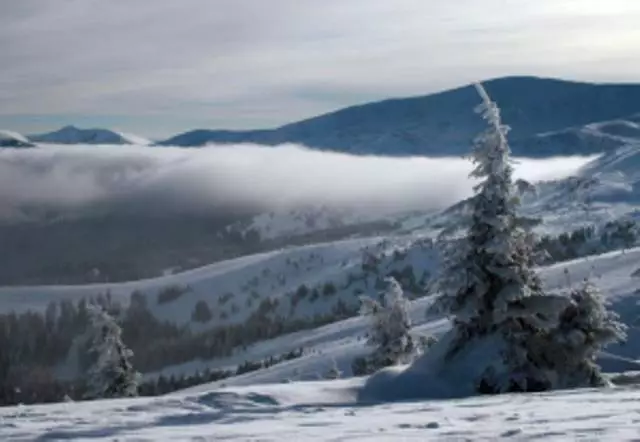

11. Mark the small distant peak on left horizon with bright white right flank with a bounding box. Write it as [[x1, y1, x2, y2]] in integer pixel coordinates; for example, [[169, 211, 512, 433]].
[[29, 126, 151, 145]]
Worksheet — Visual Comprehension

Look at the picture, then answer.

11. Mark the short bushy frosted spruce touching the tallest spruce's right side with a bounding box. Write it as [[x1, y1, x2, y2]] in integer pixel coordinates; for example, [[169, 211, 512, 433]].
[[534, 280, 627, 388]]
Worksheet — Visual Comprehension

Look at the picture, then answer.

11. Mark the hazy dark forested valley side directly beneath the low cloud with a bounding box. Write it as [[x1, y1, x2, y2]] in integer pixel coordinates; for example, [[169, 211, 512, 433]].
[[0, 207, 396, 285]]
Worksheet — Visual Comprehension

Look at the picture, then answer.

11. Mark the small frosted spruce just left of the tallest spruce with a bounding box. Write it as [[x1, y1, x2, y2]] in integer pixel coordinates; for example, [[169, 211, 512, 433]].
[[359, 278, 416, 373]]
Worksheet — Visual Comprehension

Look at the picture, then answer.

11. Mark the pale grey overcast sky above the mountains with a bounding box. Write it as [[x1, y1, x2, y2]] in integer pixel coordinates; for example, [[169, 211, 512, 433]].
[[0, 0, 640, 137]]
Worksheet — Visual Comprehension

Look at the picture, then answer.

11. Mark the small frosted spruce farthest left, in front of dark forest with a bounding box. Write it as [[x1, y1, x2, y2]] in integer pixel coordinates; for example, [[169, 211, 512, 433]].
[[85, 306, 140, 399]]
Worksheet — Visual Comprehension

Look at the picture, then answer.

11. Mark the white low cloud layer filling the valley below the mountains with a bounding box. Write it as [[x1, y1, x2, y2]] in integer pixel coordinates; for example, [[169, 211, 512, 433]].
[[0, 145, 587, 221]]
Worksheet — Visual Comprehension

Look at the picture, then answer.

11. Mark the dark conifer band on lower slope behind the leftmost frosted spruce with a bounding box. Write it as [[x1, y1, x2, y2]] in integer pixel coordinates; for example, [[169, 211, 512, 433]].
[[0, 286, 356, 403]]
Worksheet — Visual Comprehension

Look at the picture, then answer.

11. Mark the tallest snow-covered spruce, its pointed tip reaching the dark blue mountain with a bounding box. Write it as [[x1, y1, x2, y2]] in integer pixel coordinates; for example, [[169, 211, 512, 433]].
[[434, 84, 569, 393]]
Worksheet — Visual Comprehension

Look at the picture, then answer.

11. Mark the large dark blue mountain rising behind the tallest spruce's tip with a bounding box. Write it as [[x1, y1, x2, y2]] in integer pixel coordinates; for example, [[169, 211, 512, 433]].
[[159, 77, 640, 157]]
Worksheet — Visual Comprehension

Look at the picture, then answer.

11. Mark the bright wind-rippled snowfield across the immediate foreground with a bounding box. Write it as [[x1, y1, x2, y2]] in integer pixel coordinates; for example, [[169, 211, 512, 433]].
[[0, 379, 640, 442]]
